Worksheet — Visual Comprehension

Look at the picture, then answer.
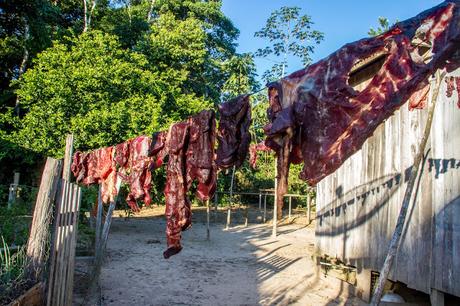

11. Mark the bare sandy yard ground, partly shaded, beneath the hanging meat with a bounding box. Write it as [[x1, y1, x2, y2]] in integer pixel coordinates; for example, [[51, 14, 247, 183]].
[[77, 210, 365, 305]]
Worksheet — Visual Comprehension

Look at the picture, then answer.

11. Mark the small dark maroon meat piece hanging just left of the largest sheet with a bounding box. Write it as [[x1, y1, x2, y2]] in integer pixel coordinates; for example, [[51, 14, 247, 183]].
[[216, 95, 251, 169]]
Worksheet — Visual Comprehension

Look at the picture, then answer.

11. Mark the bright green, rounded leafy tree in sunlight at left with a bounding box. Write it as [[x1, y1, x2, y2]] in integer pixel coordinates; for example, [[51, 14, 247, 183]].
[[13, 31, 208, 156]]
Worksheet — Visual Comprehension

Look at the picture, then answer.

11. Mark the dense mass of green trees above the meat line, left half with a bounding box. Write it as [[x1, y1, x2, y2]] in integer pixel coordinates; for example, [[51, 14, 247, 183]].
[[0, 0, 256, 157]]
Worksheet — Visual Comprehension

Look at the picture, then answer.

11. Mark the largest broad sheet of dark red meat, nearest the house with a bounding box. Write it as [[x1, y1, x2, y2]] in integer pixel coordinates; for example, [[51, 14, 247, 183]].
[[264, 2, 460, 219]]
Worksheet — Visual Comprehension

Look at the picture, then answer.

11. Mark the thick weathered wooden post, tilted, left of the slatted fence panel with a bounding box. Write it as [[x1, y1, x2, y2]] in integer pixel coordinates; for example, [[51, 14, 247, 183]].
[[27, 158, 62, 280]]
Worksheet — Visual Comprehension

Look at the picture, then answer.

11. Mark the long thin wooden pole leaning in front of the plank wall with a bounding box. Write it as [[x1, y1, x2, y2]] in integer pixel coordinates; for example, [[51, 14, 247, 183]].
[[371, 70, 445, 306]]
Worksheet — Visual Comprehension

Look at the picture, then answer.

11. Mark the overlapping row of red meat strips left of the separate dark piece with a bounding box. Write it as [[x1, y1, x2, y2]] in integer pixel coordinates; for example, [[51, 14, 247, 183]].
[[71, 111, 217, 258]]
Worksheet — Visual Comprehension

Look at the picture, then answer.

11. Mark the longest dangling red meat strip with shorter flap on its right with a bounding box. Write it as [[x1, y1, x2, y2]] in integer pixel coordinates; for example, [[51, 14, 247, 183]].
[[163, 111, 216, 258]]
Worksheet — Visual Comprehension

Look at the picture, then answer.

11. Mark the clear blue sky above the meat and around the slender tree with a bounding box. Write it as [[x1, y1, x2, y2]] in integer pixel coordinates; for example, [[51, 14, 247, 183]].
[[223, 0, 442, 80]]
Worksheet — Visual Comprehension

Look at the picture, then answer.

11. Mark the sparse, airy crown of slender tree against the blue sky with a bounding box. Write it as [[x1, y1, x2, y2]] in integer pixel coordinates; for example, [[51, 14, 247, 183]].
[[255, 6, 324, 81]]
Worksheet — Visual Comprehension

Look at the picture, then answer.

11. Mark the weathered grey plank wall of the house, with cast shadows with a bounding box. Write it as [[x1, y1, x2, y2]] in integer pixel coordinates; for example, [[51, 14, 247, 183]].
[[316, 70, 460, 296]]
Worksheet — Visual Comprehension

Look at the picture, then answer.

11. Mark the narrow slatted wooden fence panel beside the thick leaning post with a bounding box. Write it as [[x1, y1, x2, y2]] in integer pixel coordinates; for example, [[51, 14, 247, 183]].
[[47, 180, 81, 306]]
